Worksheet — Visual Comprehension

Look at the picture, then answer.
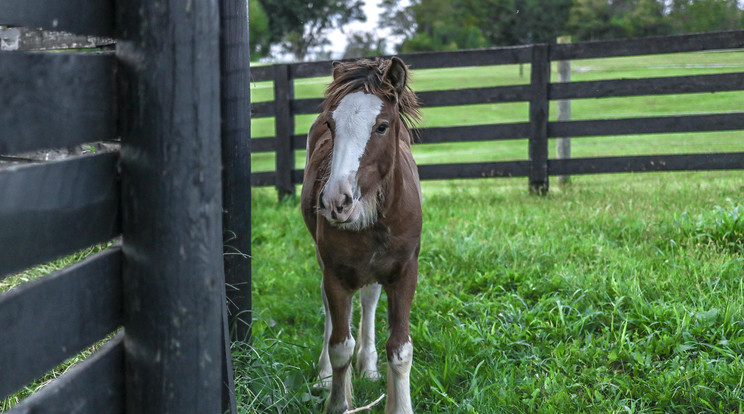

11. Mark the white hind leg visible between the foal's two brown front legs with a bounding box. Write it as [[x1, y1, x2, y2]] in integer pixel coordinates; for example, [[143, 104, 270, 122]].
[[356, 283, 382, 380]]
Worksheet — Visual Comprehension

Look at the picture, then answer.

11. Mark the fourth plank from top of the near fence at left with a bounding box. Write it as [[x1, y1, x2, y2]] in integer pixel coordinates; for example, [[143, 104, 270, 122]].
[[0, 247, 122, 398]]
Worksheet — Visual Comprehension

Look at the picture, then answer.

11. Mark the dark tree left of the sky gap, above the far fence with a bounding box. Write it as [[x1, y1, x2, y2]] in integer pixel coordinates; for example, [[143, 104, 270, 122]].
[[260, 0, 366, 61]]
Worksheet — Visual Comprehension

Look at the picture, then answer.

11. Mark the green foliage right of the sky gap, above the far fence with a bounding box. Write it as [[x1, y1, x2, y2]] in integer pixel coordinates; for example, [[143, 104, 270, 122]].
[[382, 0, 744, 52]]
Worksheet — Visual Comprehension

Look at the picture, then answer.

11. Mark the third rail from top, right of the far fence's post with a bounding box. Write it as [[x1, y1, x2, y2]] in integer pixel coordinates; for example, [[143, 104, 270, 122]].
[[548, 112, 744, 137]]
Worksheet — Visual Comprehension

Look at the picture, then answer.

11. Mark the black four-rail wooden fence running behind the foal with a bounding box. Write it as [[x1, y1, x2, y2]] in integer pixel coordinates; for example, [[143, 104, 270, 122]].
[[252, 31, 744, 194]]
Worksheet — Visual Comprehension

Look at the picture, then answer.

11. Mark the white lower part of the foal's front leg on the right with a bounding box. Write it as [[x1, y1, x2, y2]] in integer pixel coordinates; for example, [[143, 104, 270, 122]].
[[385, 338, 413, 414]]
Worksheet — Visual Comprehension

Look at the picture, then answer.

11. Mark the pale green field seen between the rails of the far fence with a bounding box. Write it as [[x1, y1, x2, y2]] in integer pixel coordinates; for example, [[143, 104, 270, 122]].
[[251, 51, 744, 171]]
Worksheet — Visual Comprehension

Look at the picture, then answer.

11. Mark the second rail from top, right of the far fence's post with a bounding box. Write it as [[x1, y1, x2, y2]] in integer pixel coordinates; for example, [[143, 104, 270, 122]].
[[548, 72, 744, 99]]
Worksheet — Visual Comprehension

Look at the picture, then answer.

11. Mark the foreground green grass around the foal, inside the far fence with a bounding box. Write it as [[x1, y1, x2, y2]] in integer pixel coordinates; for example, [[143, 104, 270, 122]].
[[244, 172, 744, 413]]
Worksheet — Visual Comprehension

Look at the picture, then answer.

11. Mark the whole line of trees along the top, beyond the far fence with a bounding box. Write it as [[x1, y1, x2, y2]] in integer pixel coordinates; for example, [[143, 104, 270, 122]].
[[249, 0, 744, 60]]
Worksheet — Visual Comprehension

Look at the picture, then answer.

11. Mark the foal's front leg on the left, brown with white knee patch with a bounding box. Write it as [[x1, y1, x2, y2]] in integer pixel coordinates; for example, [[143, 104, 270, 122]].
[[323, 273, 355, 413]]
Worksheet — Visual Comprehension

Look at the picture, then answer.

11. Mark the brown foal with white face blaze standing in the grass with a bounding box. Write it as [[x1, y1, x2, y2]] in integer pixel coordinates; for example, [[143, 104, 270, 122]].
[[300, 57, 422, 414]]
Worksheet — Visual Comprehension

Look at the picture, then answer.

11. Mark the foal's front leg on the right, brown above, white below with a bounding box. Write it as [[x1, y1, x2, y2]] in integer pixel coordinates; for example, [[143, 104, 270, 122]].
[[385, 259, 418, 414]]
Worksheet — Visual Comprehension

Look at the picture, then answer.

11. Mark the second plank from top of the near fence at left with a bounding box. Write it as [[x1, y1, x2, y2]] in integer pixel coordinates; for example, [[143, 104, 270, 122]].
[[0, 52, 116, 155]]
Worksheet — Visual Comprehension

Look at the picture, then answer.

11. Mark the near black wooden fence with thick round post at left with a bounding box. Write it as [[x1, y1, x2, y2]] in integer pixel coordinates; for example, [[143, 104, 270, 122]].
[[0, 0, 250, 414]]
